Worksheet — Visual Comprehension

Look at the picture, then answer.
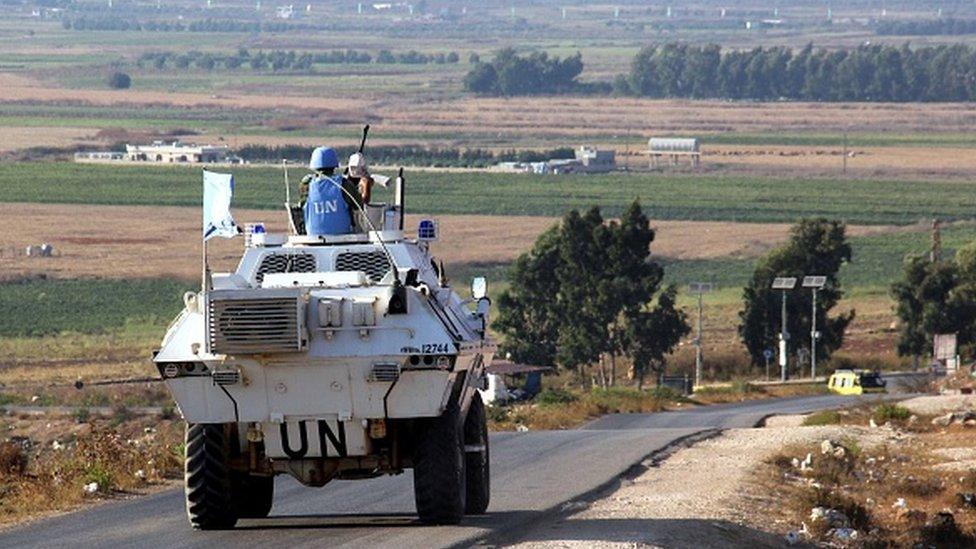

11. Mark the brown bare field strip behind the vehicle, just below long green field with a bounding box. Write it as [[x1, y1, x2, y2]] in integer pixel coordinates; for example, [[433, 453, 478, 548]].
[[0, 203, 920, 282]]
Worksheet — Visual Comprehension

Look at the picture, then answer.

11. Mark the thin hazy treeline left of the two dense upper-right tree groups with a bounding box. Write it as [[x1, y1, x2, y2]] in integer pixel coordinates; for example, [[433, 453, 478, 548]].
[[136, 48, 461, 71]]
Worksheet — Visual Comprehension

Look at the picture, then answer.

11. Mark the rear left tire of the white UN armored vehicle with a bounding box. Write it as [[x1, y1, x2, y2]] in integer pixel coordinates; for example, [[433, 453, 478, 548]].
[[183, 423, 237, 530]]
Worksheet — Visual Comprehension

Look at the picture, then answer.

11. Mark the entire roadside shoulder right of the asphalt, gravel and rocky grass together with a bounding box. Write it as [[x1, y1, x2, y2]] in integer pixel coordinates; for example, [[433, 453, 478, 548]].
[[516, 395, 976, 549]]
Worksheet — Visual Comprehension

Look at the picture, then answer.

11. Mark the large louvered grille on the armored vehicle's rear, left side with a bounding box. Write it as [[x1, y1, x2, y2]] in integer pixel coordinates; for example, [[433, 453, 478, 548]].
[[209, 296, 304, 354]]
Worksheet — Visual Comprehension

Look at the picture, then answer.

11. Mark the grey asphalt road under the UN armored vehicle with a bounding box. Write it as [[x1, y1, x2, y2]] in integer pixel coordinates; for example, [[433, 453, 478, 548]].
[[0, 396, 900, 549]]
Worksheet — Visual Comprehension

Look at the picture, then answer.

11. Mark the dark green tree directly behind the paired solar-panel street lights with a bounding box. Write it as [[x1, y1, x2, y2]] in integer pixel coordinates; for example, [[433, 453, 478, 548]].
[[739, 218, 854, 366]]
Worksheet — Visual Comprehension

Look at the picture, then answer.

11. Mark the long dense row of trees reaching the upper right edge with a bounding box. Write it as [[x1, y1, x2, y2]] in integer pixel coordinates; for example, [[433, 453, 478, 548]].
[[614, 44, 976, 101]]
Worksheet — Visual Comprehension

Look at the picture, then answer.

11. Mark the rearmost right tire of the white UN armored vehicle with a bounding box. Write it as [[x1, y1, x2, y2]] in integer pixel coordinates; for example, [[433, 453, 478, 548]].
[[413, 401, 466, 524]]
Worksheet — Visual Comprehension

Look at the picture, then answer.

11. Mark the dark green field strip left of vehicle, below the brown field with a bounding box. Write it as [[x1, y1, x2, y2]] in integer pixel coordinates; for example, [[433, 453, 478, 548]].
[[0, 279, 193, 337]]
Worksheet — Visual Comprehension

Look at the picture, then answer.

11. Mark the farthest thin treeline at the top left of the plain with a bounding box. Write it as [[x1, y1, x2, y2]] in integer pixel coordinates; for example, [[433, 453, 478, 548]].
[[61, 16, 298, 32]]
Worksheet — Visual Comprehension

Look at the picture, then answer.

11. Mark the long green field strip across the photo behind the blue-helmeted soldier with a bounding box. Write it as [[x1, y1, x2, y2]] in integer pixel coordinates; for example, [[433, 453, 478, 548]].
[[0, 163, 976, 224]]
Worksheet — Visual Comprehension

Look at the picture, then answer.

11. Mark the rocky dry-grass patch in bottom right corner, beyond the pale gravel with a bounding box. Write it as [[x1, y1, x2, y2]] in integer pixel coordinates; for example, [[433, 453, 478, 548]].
[[757, 404, 976, 547]]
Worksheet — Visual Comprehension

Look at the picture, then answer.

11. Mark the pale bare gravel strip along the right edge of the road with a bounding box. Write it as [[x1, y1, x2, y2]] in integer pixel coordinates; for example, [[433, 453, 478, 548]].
[[515, 416, 883, 549]]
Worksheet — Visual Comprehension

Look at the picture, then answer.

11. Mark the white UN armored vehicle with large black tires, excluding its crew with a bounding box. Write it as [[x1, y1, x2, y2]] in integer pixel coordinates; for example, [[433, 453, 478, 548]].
[[153, 170, 495, 529]]
